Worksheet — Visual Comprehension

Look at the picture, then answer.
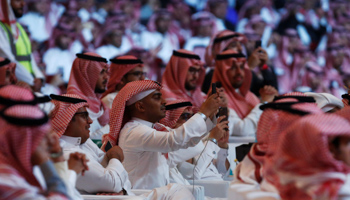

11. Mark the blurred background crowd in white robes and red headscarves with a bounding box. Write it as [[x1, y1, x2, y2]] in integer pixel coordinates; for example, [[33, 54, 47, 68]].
[[6, 0, 350, 97]]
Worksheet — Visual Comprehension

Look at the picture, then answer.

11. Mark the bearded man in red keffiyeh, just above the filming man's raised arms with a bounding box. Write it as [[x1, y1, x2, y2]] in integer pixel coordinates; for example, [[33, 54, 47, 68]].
[[162, 49, 205, 111]]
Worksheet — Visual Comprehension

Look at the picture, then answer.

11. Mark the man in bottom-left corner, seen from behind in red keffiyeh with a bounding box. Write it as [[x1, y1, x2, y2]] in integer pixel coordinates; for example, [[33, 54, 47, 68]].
[[0, 105, 68, 199]]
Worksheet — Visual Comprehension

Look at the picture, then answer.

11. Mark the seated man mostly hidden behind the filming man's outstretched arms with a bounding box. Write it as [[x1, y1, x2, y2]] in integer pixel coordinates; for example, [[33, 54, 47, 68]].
[[160, 100, 230, 180]]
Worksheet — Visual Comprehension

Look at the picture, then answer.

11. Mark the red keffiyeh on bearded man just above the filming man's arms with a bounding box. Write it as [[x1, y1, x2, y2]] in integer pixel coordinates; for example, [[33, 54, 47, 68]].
[[162, 49, 205, 108]]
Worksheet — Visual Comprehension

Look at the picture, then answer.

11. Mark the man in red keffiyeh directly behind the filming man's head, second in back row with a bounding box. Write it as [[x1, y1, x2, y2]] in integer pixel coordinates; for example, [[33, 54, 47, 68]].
[[102, 55, 145, 109]]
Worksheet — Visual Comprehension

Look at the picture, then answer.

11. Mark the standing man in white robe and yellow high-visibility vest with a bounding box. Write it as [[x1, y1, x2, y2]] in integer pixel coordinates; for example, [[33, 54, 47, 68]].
[[0, 0, 44, 89]]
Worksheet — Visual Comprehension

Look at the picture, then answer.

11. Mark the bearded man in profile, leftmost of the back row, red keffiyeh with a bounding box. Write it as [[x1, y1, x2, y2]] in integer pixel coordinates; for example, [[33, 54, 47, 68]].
[[67, 53, 109, 140]]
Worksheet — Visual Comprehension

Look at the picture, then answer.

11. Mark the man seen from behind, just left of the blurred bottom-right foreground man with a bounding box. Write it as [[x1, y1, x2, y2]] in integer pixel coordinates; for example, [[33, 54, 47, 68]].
[[233, 92, 322, 188]]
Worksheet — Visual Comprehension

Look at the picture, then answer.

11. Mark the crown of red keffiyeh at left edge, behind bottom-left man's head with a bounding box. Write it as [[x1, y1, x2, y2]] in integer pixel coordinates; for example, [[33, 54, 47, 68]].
[[0, 85, 37, 110]]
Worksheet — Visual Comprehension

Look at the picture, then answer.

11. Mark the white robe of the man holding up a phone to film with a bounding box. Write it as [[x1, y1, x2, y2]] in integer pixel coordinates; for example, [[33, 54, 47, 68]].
[[119, 114, 208, 189]]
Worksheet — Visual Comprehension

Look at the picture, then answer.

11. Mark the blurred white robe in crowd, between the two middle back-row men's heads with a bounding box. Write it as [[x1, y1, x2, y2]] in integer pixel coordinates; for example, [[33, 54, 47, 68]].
[[141, 31, 180, 64]]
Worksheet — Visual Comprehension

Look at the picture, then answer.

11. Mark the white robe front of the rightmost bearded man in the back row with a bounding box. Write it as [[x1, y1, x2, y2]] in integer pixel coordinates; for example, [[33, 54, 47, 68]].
[[228, 104, 262, 136]]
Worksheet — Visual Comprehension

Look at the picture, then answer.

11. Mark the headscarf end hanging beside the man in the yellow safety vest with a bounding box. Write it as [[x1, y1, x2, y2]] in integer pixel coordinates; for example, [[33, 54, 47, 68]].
[[0, 0, 19, 39]]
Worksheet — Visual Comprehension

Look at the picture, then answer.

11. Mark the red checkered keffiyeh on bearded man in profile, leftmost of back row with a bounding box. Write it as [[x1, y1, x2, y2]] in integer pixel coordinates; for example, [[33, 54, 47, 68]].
[[67, 53, 109, 126]]
